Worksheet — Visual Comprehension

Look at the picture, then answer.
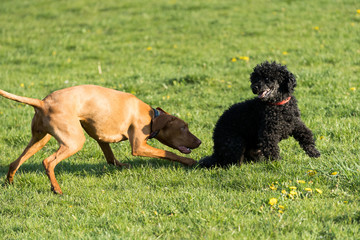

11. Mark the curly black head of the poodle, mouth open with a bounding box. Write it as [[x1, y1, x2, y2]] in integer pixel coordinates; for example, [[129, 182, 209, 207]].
[[250, 61, 296, 102]]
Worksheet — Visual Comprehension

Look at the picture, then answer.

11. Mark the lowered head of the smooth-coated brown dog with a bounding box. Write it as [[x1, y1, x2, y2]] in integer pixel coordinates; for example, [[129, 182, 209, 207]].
[[152, 108, 201, 154]]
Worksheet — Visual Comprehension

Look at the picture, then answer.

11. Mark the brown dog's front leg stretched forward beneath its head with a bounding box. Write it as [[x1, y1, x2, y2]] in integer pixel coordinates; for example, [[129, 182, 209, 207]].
[[131, 143, 196, 166]]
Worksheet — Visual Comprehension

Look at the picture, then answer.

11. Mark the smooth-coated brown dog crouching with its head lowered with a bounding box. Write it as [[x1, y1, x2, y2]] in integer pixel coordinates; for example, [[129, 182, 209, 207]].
[[0, 85, 201, 194]]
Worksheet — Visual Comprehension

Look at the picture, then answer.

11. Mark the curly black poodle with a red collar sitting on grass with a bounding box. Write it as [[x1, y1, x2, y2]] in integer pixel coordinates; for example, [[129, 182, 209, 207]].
[[199, 61, 320, 168]]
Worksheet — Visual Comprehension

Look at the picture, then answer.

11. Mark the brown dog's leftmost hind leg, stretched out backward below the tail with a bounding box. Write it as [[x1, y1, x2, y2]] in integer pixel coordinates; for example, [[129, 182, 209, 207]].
[[7, 133, 51, 184]]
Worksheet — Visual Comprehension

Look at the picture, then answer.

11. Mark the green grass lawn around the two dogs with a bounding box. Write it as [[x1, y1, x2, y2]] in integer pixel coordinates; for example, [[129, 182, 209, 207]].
[[0, 0, 360, 239]]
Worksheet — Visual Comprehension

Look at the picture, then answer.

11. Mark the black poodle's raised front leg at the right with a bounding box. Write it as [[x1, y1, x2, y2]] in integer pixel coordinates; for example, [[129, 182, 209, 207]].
[[292, 121, 321, 158]]
